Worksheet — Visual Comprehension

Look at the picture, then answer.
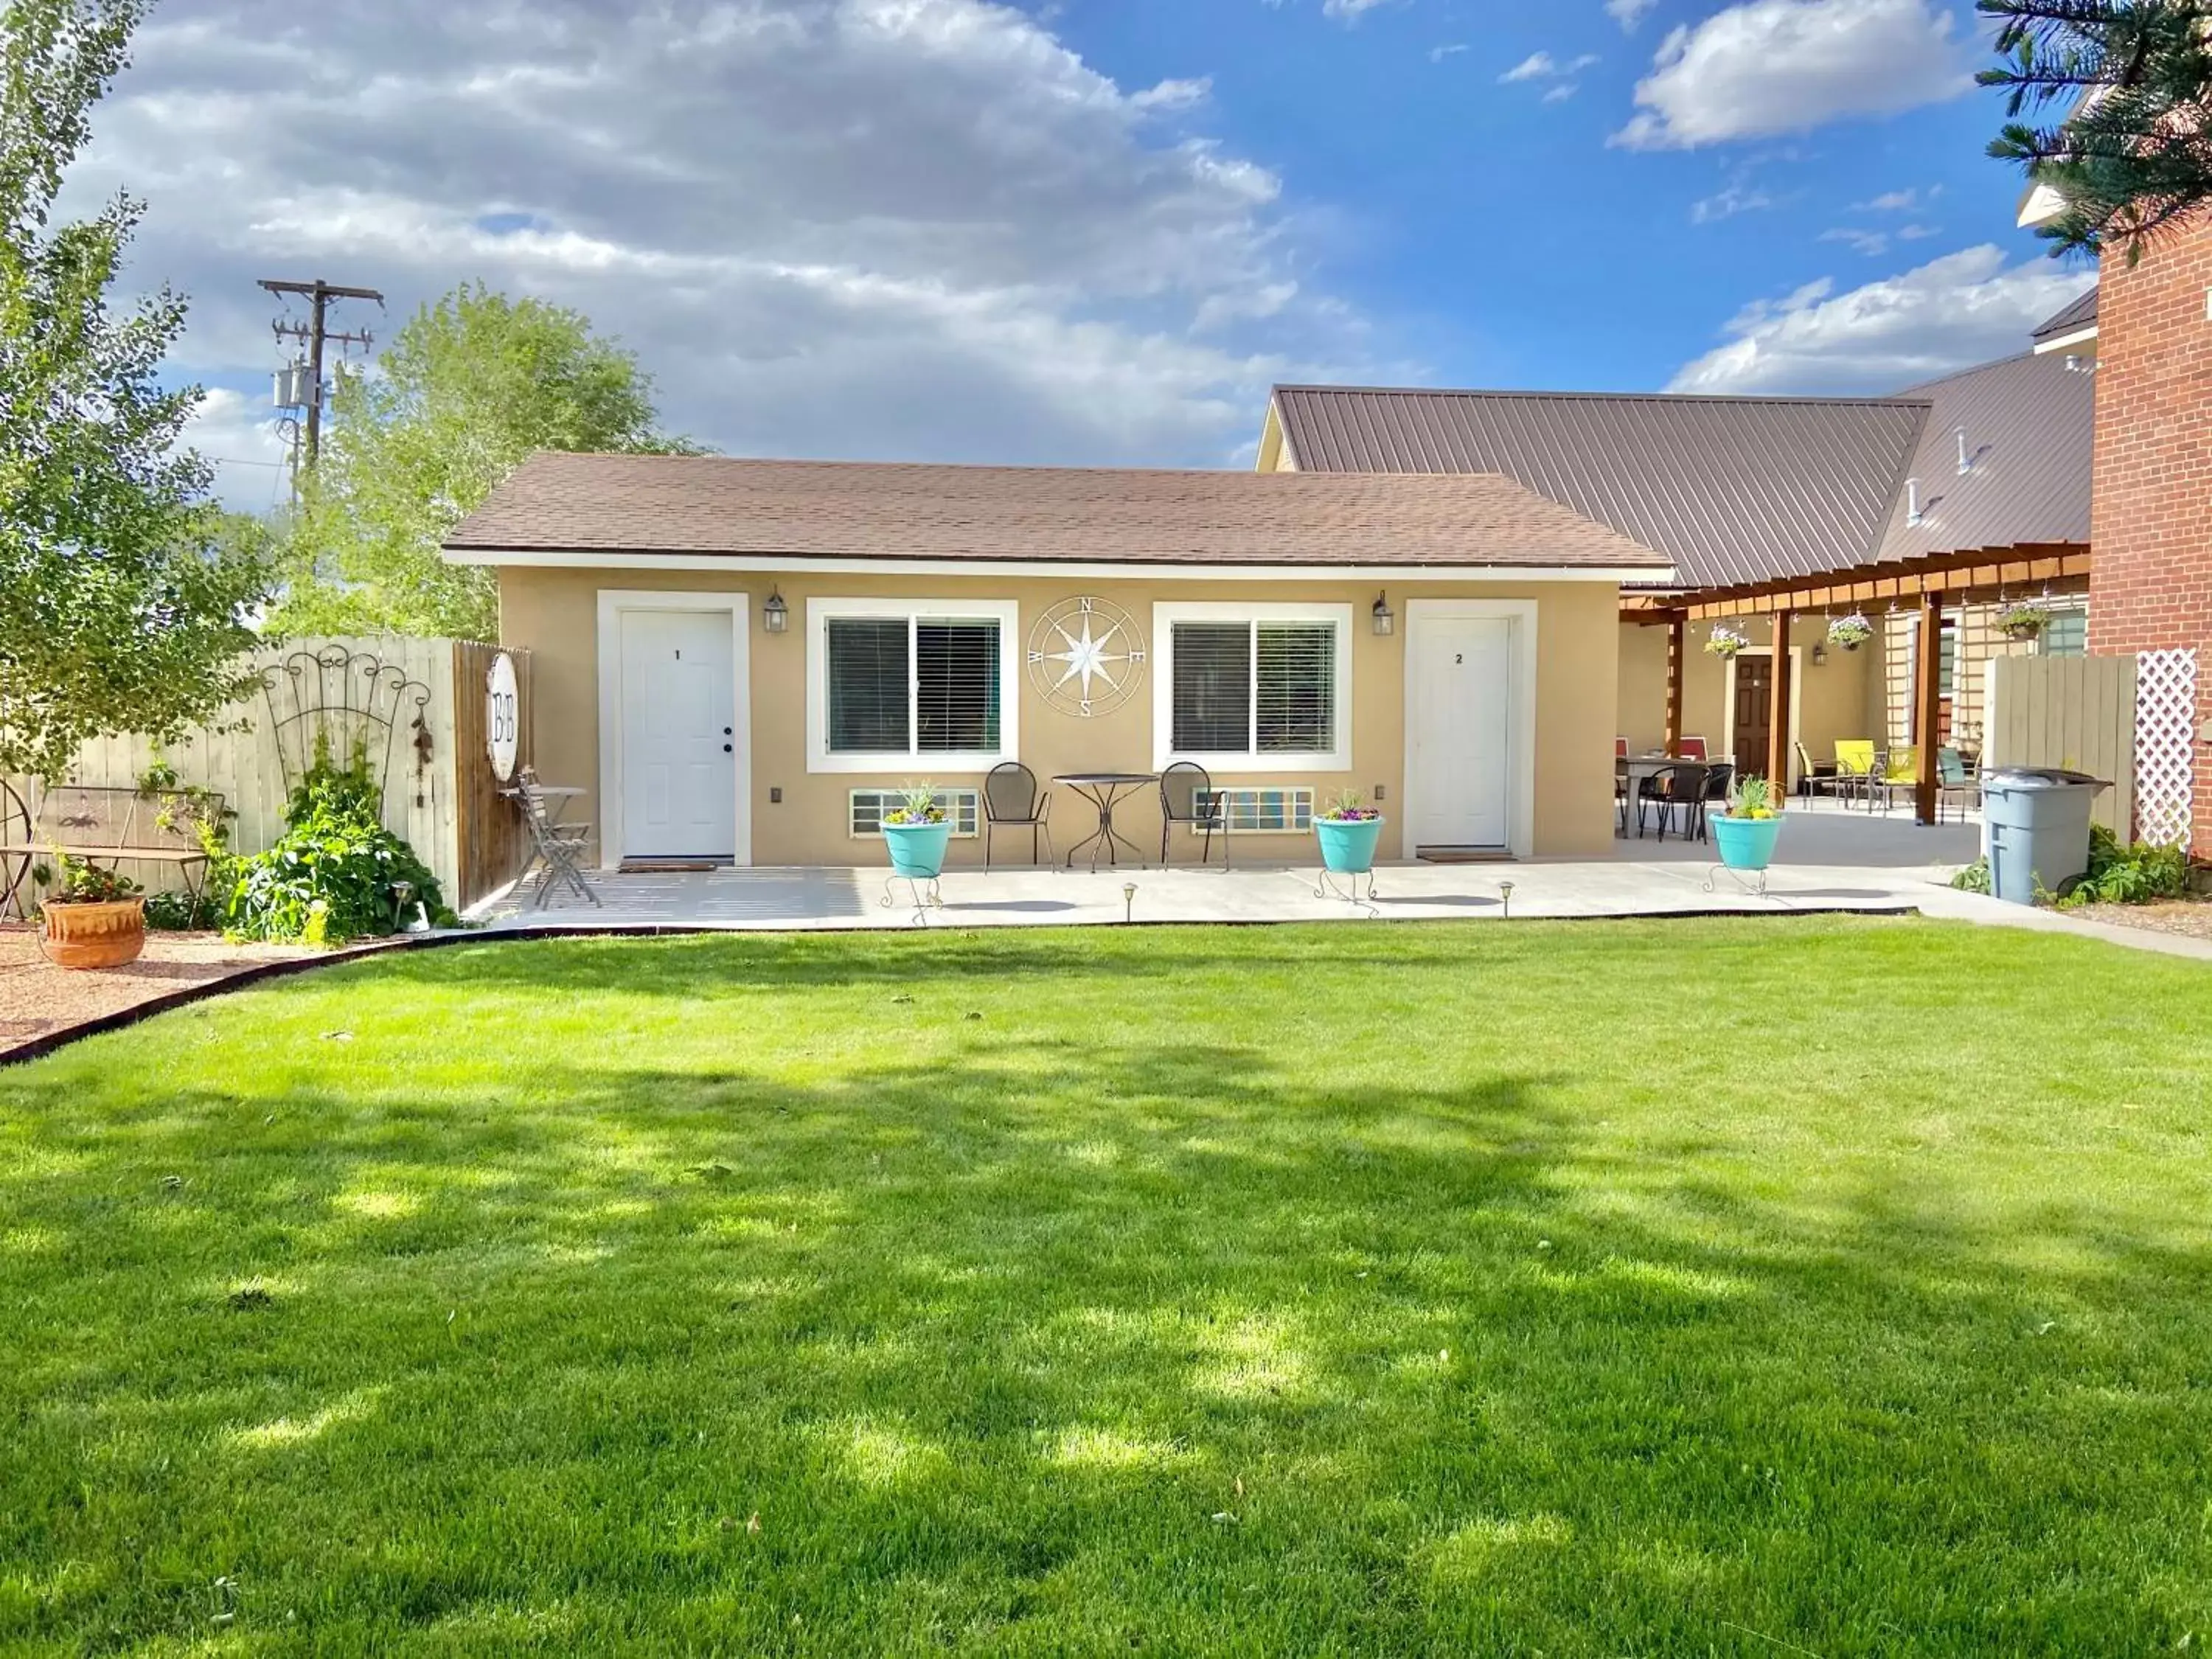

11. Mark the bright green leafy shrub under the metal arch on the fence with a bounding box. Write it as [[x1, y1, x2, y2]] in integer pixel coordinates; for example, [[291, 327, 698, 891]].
[[221, 748, 458, 945]]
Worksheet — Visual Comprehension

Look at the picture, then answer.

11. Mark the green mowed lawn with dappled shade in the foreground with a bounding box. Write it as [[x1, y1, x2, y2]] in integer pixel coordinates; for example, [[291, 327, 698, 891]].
[[0, 920, 2212, 1659]]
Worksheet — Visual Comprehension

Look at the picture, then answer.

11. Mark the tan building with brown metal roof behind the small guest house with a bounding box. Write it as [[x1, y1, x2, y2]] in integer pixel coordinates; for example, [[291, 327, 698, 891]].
[[1259, 343, 2093, 805]]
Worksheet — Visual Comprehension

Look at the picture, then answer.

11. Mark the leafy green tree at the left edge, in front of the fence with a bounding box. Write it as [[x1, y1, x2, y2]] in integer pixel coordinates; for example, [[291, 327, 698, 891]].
[[0, 0, 268, 776]]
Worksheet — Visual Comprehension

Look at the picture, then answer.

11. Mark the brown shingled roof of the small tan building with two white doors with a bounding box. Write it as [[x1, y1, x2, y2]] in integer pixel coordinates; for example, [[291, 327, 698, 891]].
[[445, 453, 1668, 577]]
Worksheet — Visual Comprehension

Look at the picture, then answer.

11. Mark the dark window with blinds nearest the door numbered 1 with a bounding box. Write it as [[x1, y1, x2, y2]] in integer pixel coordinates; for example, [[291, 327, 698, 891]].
[[823, 617, 1002, 754]]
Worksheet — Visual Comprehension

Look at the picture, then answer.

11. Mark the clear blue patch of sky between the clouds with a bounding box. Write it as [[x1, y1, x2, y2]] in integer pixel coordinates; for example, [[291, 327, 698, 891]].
[[1048, 0, 2088, 392]]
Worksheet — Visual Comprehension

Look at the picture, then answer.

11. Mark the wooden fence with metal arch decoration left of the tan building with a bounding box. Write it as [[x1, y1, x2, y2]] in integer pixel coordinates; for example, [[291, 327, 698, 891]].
[[7, 635, 531, 925]]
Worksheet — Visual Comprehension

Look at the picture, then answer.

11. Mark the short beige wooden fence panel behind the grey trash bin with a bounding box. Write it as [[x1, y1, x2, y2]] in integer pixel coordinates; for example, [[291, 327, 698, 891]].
[[1982, 657, 2137, 841]]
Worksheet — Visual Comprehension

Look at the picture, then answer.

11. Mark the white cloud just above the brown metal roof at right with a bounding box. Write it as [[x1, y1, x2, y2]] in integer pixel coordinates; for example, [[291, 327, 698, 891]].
[[1668, 246, 2086, 394]]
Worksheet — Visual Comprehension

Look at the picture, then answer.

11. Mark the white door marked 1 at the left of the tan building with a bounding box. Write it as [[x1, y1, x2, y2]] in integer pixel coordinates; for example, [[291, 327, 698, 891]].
[[622, 611, 745, 858]]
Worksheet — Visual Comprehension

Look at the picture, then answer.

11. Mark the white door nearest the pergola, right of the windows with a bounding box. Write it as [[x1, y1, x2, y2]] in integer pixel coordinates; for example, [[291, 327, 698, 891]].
[[1407, 617, 1513, 847]]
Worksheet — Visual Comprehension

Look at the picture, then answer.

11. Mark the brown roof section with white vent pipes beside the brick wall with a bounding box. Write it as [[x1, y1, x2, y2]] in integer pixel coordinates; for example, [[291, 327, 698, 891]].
[[1880, 354, 2097, 562]]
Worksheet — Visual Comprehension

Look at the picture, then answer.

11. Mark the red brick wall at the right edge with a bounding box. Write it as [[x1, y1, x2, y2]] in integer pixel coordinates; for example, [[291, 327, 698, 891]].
[[2088, 219, 2212, 854]]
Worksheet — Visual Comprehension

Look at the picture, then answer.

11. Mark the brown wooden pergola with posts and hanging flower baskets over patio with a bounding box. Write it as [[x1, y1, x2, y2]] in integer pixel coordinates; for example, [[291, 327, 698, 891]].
[[1621, 544, 2090, 823]]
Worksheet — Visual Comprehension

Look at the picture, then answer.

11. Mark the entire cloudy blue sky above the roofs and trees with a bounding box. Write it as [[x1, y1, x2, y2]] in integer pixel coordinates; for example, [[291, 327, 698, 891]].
[[77, 0, 2088, 504]]
